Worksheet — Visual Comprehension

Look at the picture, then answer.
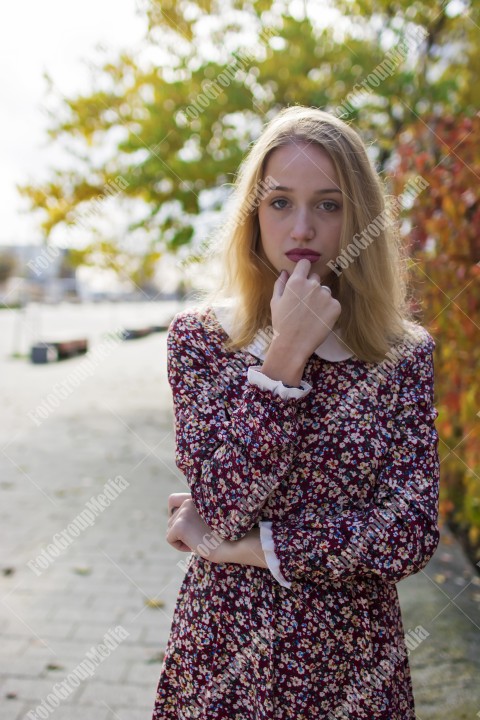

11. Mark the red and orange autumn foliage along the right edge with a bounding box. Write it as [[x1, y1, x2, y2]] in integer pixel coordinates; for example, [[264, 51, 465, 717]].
[[393, 115, 480, 560]]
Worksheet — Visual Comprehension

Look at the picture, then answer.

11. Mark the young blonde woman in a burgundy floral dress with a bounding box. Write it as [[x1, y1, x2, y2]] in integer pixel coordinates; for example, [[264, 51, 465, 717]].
[[153, 107, 439, 720]]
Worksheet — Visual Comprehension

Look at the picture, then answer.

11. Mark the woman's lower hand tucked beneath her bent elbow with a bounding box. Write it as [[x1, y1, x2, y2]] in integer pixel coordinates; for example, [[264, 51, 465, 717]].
[[167, 493, 224, 562]]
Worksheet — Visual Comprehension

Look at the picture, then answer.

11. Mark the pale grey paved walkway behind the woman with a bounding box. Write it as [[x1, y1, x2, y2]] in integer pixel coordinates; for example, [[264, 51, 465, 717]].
[[0, 318, 480, 720]]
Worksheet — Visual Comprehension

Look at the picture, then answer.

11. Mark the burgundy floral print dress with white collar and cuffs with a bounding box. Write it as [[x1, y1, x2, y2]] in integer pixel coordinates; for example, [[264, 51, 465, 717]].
[[153, 307, 439, 720]]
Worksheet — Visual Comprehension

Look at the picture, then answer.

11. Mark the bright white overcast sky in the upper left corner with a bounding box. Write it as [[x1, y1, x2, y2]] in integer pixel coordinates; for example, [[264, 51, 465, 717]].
[[0, 0, 146, 244]]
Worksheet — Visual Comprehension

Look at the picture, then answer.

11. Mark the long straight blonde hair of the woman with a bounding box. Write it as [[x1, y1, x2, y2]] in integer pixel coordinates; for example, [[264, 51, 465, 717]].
[[202, 106, 413, 362]]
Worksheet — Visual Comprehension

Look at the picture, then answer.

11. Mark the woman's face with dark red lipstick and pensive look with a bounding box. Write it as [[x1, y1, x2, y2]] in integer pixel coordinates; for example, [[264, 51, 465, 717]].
[[258, 142, 343, 282]]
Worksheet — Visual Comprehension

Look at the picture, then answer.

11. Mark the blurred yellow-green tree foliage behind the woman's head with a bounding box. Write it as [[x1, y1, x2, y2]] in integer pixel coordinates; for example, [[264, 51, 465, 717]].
[[16, 0, 480, 286]]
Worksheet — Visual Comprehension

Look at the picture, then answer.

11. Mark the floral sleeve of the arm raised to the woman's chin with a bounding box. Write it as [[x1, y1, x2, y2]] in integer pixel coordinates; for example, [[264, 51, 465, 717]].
[[167, 312, 308, 540]]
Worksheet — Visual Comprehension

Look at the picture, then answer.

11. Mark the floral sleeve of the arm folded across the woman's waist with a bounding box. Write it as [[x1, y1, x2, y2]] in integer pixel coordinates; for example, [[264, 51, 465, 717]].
[[272, 336, 439, 583]]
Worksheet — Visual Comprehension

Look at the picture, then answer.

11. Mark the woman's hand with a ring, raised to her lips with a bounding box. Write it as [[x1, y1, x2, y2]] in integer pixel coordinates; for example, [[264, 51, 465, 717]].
[[270, 258, 342, 365]]
